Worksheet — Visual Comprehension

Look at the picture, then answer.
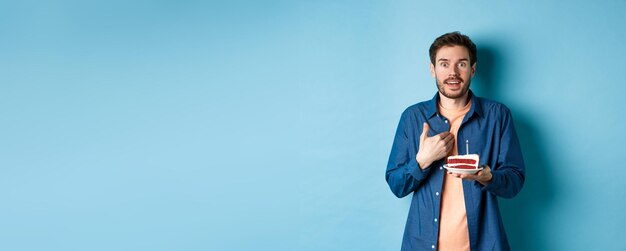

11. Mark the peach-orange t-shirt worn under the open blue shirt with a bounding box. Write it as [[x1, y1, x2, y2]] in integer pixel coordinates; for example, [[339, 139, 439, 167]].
[[437, 101, 472, 251]]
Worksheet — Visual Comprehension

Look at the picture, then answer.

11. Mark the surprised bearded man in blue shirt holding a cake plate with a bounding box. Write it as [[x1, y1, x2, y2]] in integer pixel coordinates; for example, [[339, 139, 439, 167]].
[[385, 32, 525, 251]]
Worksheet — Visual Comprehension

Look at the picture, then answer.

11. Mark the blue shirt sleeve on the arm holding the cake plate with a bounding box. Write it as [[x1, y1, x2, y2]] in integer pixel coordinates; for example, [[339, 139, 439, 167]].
[[485, 107, 525, 198]]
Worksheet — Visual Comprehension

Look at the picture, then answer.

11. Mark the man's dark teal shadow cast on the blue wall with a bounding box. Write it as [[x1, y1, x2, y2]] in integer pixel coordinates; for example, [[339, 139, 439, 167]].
[[473, 44, 559, 251]]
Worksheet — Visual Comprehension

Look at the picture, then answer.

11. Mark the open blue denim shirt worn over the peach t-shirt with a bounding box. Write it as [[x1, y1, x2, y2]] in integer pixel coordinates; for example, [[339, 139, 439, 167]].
[[385, 91, 525, 251]]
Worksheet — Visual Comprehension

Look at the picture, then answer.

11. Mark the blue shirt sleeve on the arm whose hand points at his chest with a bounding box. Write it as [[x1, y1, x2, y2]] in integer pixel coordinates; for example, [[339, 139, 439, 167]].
[[385, 111, 431, 198]]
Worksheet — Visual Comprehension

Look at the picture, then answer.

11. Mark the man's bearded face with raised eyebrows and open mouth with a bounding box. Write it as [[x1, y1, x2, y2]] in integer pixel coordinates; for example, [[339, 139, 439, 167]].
[[430, 45, 476, 99]]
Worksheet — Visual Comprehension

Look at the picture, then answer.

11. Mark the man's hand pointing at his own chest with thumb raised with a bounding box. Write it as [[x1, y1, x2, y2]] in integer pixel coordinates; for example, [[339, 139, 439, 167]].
[[415, 123, 454, 169]]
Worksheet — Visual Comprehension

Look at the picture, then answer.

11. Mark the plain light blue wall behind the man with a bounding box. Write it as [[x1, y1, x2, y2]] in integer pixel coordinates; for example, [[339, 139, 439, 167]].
[[0, 0, 626, 251]]
